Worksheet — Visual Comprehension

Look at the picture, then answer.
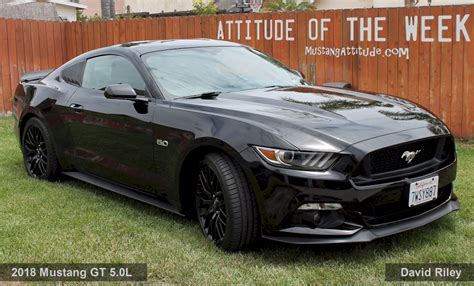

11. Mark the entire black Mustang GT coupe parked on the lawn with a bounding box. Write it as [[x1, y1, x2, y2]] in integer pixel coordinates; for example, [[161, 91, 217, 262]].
[[14, 40, 459, 250]]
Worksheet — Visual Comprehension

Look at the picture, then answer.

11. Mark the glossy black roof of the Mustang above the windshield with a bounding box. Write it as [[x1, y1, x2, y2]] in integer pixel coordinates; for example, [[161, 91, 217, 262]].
[[114, 39, 242, 54]]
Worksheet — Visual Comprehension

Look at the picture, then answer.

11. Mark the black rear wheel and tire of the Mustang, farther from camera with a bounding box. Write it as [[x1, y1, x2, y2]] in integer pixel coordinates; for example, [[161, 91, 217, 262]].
[[21, 117, 60, 181]]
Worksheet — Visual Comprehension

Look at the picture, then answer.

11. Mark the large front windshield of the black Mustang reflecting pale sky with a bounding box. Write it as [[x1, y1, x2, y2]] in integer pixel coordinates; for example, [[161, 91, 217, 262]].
[[143, 47, 303, 98]]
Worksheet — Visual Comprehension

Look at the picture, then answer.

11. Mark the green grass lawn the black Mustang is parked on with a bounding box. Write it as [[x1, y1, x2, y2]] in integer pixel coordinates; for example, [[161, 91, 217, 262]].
[[0, 117, 474, 284]]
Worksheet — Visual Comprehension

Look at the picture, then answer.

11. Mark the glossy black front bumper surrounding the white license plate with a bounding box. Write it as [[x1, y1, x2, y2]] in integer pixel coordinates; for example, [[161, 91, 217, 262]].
[[243, 142, 459, 244]]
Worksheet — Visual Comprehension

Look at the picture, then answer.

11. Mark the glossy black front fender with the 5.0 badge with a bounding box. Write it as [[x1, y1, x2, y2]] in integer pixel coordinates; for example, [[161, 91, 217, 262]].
[[153, 101, 295, 209]]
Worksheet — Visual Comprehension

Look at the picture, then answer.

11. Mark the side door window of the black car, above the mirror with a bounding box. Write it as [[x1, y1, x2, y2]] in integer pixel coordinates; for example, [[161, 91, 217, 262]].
[[82, 56, 145, 95]]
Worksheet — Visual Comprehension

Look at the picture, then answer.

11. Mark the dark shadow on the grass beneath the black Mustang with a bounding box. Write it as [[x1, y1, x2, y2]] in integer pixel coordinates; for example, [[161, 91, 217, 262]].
[[57, 173, 455, 265]]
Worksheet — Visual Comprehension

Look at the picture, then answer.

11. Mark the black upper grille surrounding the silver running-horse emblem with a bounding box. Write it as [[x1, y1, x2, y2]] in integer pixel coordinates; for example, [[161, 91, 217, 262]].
[[370, 138, 440, 174]]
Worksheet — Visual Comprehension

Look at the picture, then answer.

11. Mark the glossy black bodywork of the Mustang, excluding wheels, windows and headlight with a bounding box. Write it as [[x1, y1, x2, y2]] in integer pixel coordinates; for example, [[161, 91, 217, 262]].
[[14, 40, 459, 248]]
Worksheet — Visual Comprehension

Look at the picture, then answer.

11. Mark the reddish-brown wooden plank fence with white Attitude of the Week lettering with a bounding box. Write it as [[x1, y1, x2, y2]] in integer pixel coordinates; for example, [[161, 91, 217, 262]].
[[0, 5, 474, 137]]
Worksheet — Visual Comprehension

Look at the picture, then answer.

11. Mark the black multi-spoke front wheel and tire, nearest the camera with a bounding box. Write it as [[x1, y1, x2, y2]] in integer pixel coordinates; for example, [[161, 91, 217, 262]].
[[195, 153, 259, 251]]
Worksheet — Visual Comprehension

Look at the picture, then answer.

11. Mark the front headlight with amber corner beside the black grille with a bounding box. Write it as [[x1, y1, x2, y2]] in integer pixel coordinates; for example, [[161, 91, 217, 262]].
[[254, 146, 339, 171]]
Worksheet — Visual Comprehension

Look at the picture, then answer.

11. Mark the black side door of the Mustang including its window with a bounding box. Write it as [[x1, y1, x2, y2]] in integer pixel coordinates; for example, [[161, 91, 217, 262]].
[[68, 55, 155, 191]]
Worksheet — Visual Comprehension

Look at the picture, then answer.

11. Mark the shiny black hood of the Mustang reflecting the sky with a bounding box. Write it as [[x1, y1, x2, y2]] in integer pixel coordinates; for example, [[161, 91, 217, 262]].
[[171, 86, 449, 152]]
